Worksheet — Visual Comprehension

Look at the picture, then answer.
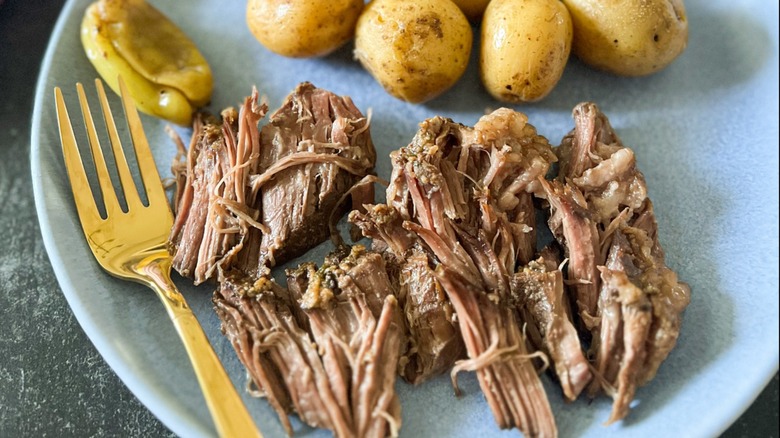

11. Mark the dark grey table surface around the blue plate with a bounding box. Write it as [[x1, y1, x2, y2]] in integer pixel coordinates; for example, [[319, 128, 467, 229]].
[[0, 0, 778, 437]]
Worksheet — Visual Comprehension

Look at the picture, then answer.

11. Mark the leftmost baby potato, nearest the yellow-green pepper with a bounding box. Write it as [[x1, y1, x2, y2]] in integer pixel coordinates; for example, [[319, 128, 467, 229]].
[[246, 0, 363, 58]]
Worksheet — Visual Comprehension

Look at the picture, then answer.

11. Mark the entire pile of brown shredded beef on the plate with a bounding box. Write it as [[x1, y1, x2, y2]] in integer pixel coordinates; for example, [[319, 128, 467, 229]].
[[175, 90, 690, 437]]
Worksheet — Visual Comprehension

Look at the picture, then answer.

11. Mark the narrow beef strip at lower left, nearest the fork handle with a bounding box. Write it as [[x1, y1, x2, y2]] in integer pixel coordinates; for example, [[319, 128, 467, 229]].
[[213, 271, 312, 435]]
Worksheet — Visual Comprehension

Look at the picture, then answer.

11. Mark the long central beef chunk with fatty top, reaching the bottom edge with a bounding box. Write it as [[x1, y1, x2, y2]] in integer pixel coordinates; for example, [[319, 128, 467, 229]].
[[351, 109, 556, 436]]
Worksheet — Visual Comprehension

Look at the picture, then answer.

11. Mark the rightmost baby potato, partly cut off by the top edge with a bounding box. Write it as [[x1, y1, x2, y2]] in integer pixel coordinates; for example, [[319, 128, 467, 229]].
[[564, 0, 688, 76]]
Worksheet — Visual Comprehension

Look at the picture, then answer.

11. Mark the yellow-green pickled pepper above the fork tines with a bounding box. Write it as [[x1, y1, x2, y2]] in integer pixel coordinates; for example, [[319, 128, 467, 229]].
[[81, 0, 213, 125]]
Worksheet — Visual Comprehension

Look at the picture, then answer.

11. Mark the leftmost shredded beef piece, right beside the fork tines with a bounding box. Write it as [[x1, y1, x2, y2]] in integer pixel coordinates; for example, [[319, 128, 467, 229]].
[[169, 89, 266, 284]]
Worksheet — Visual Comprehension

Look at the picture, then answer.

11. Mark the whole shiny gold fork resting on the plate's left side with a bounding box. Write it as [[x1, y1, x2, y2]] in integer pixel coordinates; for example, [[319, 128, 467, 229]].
[[54, 78, 260, 437]]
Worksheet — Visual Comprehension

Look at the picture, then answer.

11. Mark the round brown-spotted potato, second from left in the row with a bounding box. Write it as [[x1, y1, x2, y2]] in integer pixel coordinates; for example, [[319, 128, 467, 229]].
[[355, 0, 473, 103]]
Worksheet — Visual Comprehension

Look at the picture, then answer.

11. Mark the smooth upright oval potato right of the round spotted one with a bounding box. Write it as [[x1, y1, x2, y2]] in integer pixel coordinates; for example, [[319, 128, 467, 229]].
[[479, 0, 572, 103]]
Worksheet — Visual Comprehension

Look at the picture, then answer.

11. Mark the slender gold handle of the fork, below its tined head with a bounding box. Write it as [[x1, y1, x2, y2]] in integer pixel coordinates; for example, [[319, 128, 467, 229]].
[[136, 250, 261, 437]]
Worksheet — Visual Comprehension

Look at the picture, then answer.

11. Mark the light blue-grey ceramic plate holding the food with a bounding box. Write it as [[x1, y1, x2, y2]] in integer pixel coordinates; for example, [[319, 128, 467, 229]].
[[31, 0, 778, 437]]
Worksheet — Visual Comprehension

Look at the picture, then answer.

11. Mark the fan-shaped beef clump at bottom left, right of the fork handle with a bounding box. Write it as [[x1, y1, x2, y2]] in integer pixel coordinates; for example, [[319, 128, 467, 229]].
[[214, 247, 404, 437]]
